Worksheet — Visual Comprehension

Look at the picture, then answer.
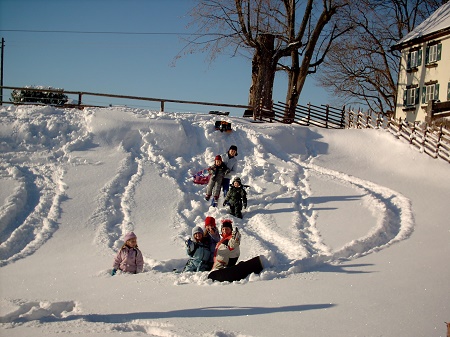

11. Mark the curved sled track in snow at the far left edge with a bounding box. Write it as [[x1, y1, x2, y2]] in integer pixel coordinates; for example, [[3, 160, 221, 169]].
[[0, 165, 65, 266]]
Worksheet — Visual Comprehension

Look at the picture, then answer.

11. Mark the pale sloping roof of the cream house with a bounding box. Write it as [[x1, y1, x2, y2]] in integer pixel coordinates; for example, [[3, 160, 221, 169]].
[[392, 1, 450, 50]]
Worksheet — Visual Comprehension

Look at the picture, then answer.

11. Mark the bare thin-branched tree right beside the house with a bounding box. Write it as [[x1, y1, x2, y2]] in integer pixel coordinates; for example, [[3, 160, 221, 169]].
[[318, 0, 442, 114]]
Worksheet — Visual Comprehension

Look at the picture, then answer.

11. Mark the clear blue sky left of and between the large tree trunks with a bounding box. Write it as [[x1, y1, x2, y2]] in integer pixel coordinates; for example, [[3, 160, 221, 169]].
[[0, 0, 332, 115]]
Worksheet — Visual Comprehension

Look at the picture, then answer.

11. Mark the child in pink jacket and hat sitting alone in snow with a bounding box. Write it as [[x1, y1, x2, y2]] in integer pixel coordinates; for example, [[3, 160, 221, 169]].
[[111, 232, 144, 276]]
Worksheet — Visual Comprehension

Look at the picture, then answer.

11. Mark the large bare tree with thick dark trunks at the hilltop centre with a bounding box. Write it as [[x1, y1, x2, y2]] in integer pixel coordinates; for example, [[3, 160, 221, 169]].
[[186, 0, 348, 117]]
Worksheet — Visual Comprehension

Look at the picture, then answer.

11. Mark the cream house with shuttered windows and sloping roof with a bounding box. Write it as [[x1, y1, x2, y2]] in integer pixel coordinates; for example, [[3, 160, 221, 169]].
[[392, 2, 450, 122]]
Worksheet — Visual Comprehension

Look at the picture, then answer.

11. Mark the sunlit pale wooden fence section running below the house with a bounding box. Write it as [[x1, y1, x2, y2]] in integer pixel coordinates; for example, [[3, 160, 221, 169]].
[[346, 110, 450, 163]]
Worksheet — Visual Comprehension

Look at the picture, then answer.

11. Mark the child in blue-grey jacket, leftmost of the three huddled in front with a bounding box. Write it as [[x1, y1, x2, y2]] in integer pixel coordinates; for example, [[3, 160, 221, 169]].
[[183, 226, 212, 271]]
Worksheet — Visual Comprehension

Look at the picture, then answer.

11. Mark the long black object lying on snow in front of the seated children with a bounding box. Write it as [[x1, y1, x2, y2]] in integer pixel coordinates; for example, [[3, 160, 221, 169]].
[[208, 256, 263, 282]]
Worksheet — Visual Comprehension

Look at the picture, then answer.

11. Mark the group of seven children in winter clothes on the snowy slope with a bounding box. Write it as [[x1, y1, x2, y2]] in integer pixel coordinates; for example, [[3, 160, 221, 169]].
[[111, 145, 247, 275]]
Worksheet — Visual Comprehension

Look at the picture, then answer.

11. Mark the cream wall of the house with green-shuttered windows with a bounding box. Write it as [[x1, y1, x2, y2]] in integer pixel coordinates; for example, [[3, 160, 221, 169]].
[[395, 35, 450, 122]]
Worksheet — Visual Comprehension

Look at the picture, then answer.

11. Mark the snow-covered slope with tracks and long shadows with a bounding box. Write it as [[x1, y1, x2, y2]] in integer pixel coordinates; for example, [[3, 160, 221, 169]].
[[0, 106, 450, 337]]
